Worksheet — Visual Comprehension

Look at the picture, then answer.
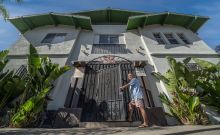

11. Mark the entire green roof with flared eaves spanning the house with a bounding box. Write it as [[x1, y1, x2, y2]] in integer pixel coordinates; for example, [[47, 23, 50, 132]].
[[8, 8, 209, 33]]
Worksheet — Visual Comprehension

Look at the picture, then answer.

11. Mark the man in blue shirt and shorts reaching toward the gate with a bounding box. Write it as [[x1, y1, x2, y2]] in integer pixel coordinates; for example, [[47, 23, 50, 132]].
[[120, 73, 148, 128]]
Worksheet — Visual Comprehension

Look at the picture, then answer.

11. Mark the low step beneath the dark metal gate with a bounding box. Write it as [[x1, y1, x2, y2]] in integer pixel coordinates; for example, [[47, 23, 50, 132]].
[[79, 121, 141, 128]]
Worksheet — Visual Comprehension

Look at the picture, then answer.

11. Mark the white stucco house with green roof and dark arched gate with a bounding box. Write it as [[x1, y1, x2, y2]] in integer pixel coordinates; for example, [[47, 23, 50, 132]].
[[6, 8, 219, 124]]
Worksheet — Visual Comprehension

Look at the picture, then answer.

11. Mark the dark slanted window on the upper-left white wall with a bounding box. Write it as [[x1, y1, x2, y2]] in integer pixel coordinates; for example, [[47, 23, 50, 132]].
[[41, 33, 66, 44]]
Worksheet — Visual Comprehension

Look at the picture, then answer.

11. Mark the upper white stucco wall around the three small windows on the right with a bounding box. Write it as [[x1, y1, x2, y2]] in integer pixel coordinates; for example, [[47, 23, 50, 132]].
[[139, 25, 215, 54]]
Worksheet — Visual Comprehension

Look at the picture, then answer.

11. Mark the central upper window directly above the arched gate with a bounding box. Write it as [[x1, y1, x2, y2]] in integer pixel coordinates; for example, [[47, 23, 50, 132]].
[[99, 35, 119, 44]]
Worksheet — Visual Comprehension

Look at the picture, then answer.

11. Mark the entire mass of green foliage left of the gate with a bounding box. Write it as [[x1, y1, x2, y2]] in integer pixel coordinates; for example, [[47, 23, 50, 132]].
[[0, 45, 70, 127]]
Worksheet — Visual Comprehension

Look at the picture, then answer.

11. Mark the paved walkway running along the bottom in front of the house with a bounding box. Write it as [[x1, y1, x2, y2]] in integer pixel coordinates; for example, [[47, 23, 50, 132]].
[[0, 125, 220, 135]]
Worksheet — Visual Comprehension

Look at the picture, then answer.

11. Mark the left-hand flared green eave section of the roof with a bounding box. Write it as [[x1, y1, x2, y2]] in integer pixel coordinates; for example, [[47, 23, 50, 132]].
[[9, 13, 92, 33]]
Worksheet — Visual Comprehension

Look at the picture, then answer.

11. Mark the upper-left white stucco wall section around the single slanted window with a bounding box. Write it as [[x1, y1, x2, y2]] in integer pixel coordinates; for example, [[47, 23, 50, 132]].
[[24, 25, 80, 54]]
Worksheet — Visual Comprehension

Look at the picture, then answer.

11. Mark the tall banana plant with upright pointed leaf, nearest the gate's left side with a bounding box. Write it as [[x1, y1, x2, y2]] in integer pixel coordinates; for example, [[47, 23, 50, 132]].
[[11, 45, 70, 127]]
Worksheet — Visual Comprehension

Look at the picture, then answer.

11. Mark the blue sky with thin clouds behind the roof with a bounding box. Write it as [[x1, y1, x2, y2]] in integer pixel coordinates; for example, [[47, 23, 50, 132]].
[[0, 0, 220, 50]]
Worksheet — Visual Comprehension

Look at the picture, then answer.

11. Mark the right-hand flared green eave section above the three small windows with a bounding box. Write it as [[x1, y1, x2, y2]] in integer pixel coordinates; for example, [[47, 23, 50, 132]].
[[127, 12, 209, 32]]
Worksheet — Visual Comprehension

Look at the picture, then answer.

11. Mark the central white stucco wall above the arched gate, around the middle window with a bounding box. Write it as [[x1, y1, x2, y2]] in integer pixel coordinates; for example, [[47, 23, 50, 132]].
[[76, 25, 150, 61]]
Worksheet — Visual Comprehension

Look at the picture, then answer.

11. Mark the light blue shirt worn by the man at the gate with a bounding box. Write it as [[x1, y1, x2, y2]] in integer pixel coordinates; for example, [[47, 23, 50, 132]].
[[129, 78, 143, 100]]
